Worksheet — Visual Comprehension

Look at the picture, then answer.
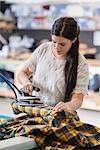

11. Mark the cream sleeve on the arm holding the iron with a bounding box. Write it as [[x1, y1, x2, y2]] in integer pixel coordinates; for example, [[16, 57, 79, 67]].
[[25, 44, 45, 73]]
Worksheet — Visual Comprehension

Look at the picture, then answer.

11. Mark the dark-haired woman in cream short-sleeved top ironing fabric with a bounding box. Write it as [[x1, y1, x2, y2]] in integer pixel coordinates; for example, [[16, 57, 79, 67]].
[[18, 17, 89, 112]]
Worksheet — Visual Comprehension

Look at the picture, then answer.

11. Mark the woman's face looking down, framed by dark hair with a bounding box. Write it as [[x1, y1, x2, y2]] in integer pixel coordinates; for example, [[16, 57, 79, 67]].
[[52, 35, 72, 58]]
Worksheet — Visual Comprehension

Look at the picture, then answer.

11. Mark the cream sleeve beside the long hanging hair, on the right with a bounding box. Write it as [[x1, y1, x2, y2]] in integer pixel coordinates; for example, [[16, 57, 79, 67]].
[[73, 55, 89, 95]]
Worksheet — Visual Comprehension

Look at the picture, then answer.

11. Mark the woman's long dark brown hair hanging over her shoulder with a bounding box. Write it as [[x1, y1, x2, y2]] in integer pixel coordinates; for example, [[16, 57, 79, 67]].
[[51, 17, 80, 101]]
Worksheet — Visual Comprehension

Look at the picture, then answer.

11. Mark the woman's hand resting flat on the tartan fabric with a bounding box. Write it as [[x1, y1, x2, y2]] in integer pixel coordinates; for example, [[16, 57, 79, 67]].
[[53, 102, 74, 113]]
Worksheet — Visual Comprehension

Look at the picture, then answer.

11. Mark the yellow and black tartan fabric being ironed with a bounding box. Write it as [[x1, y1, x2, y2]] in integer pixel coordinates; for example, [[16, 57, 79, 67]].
[[0, 103, 100, 150]]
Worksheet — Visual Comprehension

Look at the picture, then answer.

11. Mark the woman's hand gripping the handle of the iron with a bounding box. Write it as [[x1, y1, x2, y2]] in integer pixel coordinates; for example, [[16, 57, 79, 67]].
[[22, 81, 33, 95]]
